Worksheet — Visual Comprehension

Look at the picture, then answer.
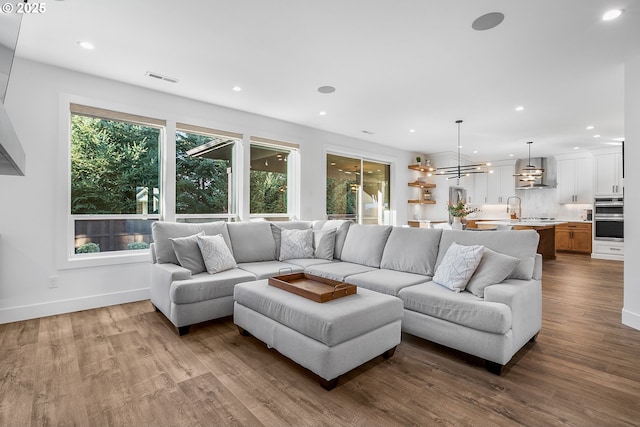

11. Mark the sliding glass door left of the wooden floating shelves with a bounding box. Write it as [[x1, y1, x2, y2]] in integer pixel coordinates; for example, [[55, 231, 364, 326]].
[[327, 154, 390, 224]]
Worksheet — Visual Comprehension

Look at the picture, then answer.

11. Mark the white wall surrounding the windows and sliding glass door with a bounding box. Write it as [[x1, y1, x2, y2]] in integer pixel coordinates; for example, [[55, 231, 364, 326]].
[[0, 59, 411, 323]]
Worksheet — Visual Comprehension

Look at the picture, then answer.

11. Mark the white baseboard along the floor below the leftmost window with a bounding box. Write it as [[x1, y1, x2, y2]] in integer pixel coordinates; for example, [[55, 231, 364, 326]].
[[0, 288, 149, 324]]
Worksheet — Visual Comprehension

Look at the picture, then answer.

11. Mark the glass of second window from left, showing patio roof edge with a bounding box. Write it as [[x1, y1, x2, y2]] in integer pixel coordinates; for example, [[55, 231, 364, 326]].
[[176, 131, 237, 214]]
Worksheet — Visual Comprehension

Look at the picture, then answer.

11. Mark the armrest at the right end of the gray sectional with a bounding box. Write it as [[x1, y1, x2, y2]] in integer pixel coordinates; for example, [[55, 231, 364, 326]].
[[484, 279, 542, 349]]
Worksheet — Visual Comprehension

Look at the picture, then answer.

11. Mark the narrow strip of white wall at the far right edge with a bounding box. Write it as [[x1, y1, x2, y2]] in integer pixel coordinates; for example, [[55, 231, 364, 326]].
[[622, 56, 640, 330]]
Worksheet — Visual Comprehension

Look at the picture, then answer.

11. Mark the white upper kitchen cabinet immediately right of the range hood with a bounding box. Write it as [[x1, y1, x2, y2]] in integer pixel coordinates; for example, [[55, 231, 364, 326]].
[[557, 157, 593, 204]]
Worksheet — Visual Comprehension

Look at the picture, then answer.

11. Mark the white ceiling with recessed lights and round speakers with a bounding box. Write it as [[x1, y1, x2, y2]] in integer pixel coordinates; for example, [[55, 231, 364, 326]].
[[17, 0, 640, 160]]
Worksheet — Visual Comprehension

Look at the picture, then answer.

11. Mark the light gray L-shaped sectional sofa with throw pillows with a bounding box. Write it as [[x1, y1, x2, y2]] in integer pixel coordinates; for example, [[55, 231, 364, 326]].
[[151, 220, 542, 374]]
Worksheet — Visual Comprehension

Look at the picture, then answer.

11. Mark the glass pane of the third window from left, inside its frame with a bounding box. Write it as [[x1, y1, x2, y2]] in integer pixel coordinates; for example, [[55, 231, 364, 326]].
[[249, 144, 290, 214]]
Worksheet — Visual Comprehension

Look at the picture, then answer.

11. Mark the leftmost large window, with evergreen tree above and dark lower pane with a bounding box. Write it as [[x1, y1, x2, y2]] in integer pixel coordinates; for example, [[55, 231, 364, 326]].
[[70, 104, 164, 253]]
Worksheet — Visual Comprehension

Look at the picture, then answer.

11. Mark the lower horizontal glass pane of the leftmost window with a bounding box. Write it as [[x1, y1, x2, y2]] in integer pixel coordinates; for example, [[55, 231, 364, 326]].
[[74, 219, 154, 254]]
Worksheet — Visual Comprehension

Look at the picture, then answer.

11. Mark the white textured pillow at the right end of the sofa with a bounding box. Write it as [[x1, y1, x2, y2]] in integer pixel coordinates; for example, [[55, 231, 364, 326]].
[[433, 242, 484, 292]]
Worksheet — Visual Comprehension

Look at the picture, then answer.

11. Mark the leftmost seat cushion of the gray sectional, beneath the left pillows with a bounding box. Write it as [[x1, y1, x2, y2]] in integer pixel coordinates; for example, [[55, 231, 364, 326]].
[[169, 268, 256, 304]]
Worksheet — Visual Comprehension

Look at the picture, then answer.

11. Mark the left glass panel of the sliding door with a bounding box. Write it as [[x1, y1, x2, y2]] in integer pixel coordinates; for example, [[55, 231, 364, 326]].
[[327, 154, 360, 219]]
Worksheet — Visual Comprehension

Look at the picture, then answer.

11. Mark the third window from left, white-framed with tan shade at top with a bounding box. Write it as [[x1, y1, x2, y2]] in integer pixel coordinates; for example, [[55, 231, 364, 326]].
[[249, 138, 297, 219]]
